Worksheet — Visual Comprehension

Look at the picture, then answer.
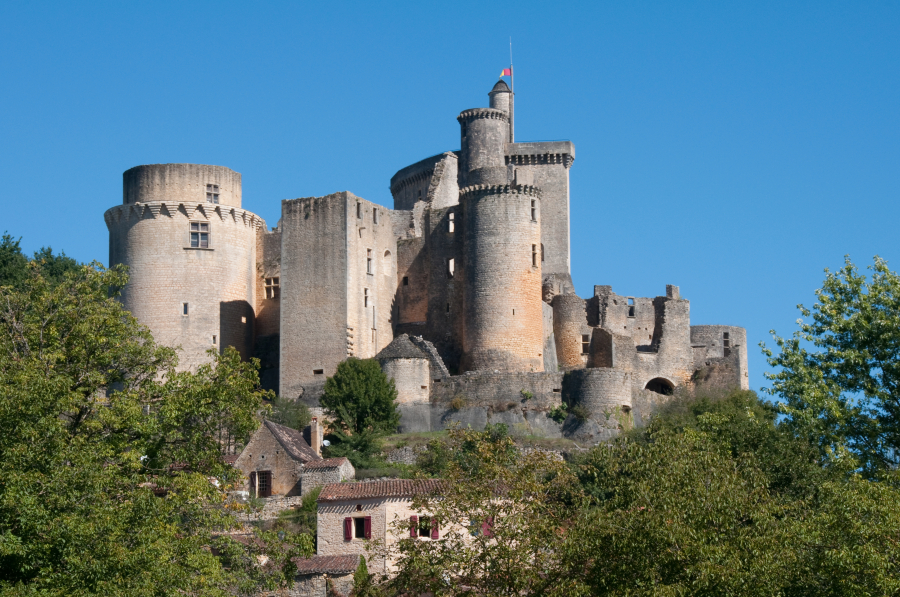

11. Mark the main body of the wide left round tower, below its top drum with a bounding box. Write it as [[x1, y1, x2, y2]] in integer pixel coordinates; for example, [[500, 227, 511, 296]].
[[105, 196, 265, 369]]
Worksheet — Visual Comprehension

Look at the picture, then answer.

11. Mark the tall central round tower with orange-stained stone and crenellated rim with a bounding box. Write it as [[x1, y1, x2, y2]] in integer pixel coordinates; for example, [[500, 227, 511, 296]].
[[460, 185, 544, 371]]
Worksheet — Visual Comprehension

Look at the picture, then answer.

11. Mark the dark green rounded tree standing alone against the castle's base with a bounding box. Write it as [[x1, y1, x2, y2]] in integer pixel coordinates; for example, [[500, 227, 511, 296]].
[[320, 358, 400, 468]]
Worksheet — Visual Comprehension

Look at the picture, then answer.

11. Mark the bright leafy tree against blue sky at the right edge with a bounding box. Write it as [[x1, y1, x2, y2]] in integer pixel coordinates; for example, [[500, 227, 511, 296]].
[[762, 256, 900, 476]]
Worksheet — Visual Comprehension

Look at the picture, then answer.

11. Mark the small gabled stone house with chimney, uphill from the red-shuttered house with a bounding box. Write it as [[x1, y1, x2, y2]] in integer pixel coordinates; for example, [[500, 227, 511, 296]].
[[234, 418, 356, 497]]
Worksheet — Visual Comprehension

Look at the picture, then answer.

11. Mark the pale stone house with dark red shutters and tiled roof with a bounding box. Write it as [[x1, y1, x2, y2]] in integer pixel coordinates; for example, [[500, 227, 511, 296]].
[[316, 479, 443, 573]]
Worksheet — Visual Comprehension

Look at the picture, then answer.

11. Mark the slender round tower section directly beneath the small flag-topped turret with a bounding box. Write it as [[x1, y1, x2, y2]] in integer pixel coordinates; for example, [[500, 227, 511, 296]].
[[456, 108, 509, 186]]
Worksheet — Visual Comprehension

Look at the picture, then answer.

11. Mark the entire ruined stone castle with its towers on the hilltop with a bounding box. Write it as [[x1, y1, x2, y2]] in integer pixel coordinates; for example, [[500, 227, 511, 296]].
[[104, 79, 748, 440]]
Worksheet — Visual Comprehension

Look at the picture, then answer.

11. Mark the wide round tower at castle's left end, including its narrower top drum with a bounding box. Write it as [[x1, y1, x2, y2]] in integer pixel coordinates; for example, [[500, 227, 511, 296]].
[[104, 164, 265, 369]]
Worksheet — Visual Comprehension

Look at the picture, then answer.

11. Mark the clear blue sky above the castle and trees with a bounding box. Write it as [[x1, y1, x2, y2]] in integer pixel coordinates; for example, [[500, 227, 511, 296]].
[[0, 0, 900, 389]]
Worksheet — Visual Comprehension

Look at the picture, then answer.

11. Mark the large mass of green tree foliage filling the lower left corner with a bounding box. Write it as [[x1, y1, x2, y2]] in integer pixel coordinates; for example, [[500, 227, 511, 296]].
[[0, 262, 312, 596]]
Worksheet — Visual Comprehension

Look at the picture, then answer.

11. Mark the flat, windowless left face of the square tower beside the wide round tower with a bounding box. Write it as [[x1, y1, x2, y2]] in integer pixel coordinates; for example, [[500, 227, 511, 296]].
[[279, 192, 350, 398]]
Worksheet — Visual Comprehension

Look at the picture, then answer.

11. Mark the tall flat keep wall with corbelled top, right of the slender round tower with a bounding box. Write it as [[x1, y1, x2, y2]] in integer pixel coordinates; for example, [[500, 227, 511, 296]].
[[505, 141, 575, 274]]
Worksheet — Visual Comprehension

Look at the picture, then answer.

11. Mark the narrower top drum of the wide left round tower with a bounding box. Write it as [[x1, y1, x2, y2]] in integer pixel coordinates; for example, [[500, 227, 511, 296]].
[[122, 164, 241, 207]]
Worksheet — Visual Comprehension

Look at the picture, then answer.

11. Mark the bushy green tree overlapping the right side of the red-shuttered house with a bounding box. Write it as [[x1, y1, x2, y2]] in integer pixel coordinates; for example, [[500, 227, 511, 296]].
[[382, 429, 588, 597]]
